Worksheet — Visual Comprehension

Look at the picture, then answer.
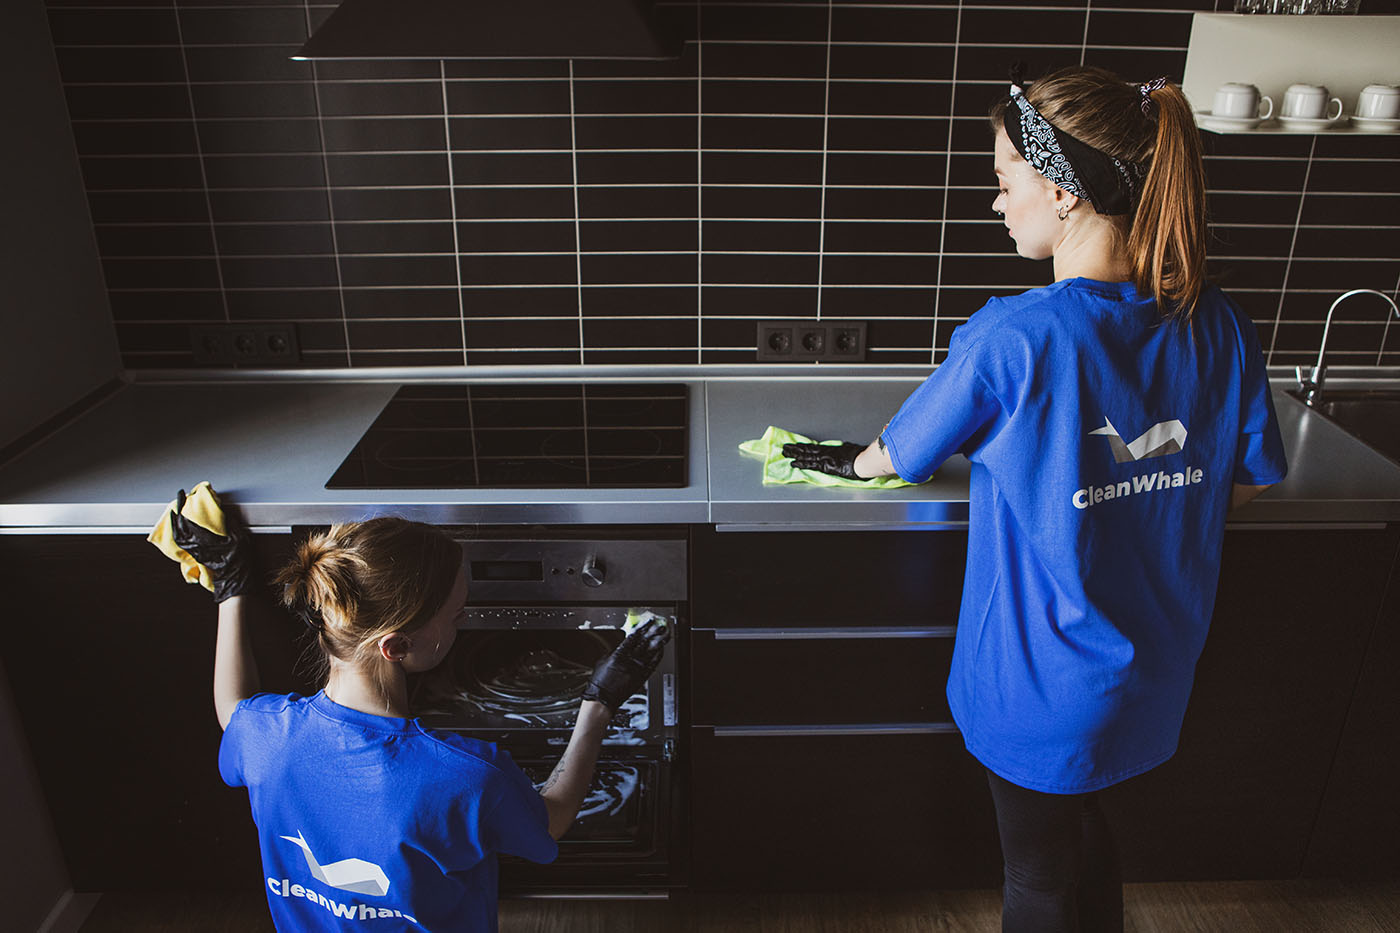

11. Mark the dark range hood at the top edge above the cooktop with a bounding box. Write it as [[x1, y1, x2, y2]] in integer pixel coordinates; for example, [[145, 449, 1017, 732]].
[[293, 0, 683, 59]]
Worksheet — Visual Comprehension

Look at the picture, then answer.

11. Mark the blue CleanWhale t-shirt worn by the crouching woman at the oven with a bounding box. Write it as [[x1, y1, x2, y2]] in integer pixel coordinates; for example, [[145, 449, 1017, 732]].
[[218, 692, 559, 933]]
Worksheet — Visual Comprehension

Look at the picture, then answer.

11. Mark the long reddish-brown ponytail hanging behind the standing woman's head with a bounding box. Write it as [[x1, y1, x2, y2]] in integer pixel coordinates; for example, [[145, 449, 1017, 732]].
[[1127, 84, 1205, 322]]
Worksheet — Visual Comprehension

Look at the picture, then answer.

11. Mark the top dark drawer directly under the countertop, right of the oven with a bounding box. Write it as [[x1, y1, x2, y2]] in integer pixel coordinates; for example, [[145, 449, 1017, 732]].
[[690, 528, 967, 629]]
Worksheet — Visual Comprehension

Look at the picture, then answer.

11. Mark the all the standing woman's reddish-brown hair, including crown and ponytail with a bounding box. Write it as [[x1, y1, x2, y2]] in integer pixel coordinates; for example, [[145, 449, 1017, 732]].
[[990, 67, 1205, 321]]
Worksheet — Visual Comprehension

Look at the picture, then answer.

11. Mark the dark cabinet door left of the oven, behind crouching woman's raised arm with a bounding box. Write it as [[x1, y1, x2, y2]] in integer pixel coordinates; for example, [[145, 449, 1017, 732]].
[[0, 535, 295, 891]]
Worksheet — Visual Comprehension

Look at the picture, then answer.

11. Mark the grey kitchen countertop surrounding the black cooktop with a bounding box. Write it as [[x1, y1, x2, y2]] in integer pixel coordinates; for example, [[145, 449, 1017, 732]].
[[0, 367, 1400, 534]]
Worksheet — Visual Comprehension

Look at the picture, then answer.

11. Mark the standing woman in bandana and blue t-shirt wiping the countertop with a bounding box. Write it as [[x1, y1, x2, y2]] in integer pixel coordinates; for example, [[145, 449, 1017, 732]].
[[785, 67, 1287, 933]]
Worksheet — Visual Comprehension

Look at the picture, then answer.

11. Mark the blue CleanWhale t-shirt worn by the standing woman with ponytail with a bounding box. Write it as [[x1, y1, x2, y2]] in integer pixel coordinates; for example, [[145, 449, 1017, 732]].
[[883, 279, 1287, 793]]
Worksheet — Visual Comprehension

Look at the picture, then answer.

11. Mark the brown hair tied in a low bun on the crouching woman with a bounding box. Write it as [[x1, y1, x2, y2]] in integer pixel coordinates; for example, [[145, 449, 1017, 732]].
[[274, 516, 462, 677]]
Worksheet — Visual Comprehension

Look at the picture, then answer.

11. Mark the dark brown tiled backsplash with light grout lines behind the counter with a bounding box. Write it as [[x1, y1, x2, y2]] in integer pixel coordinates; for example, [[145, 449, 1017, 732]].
[[48, 0, 1400, 368]]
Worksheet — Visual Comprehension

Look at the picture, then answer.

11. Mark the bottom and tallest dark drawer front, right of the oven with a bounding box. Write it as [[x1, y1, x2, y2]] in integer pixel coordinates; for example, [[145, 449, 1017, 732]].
[[690, 727, 1001, 891]]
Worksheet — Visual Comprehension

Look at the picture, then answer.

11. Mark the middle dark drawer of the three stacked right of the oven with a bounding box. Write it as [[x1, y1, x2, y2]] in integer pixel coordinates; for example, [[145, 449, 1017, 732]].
[[690, 628, 953, 726]]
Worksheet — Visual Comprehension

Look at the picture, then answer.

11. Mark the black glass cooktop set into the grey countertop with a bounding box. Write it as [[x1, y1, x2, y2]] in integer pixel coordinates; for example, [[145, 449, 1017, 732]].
[[326, 384, 687, 489]]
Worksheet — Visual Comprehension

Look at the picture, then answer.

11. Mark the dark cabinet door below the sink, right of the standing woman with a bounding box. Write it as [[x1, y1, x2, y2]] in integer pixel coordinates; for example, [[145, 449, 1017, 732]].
[[1105, 530, 1394, 881]]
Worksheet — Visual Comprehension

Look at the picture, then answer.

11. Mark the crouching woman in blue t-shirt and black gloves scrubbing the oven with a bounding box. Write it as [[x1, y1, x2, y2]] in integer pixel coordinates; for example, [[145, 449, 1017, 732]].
[[171, 504, 671, 933]]
